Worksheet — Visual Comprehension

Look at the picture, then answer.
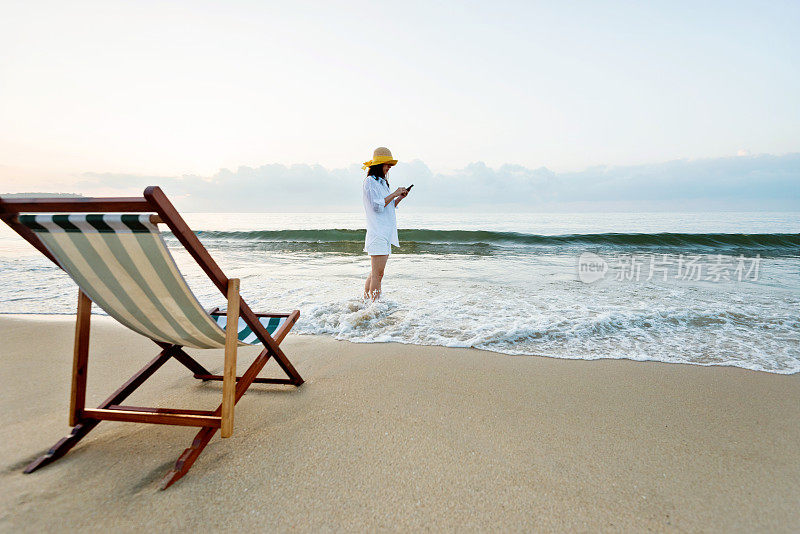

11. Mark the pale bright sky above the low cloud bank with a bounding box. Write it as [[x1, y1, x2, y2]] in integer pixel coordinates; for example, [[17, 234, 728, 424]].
[[0, 0, 800, 207]]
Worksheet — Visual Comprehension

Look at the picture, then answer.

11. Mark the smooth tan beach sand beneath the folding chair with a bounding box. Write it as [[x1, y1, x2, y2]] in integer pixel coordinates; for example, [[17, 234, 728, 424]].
[[0, 316, 800, 532]]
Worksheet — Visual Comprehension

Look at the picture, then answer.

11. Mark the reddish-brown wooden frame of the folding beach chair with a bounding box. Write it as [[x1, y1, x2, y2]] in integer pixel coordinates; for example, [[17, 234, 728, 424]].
[[0, 186, 303, 489]]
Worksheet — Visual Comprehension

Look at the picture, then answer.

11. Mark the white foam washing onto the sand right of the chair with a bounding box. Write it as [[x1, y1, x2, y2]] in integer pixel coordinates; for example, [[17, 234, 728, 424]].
[[295, 298, 800, 374]]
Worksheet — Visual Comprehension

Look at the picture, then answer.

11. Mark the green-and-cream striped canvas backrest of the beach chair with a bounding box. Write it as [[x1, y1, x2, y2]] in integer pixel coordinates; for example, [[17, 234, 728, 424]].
[[19, 213, 225, 348]]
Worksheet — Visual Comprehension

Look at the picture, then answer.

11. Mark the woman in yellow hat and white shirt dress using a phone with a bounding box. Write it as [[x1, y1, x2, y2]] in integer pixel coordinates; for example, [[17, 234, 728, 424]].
[[361, 147, 408, 300]]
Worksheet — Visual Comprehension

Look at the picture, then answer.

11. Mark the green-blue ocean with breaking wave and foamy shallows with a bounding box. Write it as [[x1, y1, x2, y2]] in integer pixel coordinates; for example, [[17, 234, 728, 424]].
[[0, 208, 800, 374]]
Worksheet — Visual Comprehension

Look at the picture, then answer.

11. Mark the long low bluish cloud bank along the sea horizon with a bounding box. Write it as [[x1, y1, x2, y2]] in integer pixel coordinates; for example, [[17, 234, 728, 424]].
[[76, 154, 800, 212]]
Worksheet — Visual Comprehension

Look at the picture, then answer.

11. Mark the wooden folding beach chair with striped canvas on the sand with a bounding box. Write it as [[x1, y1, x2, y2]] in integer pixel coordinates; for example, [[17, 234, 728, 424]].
[[0, 187, 303, 489]]
